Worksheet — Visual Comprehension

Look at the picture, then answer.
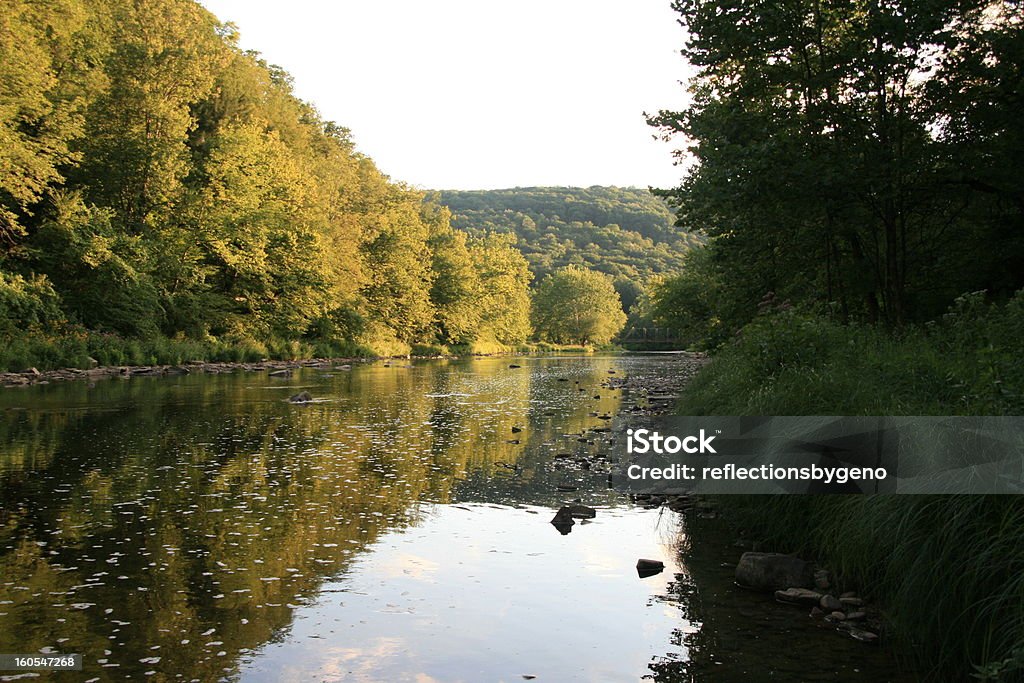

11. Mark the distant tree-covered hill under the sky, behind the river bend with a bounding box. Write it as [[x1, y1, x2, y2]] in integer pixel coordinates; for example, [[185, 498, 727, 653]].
[[438, 185, 699, 308]]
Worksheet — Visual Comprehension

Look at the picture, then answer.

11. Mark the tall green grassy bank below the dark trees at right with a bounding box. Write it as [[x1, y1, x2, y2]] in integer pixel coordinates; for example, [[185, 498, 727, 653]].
[[679, 294, 1024, 681]]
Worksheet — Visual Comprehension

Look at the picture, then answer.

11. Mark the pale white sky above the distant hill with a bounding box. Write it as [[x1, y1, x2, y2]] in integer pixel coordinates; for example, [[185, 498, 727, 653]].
[[201, 0, 689, 189]]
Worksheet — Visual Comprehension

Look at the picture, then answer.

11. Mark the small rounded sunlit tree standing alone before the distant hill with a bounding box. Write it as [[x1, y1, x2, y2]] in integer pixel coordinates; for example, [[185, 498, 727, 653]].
[[532, 265, 626, 344]]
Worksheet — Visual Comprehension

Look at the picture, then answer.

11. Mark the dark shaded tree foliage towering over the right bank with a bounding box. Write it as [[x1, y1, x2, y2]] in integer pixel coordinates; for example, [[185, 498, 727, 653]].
[[651, 0, 1024, 330]]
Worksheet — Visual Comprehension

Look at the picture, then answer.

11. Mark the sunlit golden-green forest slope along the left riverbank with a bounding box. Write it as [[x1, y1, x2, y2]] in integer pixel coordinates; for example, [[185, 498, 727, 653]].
[[0, 0, 577, 371]]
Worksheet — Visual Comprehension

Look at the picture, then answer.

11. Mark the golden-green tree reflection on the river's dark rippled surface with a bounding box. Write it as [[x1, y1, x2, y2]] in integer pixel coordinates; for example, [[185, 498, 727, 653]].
[[0, 359, 617, 680]]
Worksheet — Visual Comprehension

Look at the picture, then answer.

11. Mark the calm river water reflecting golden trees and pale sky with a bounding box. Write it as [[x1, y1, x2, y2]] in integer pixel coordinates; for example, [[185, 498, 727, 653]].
[[0, 355, 913, 683]]
